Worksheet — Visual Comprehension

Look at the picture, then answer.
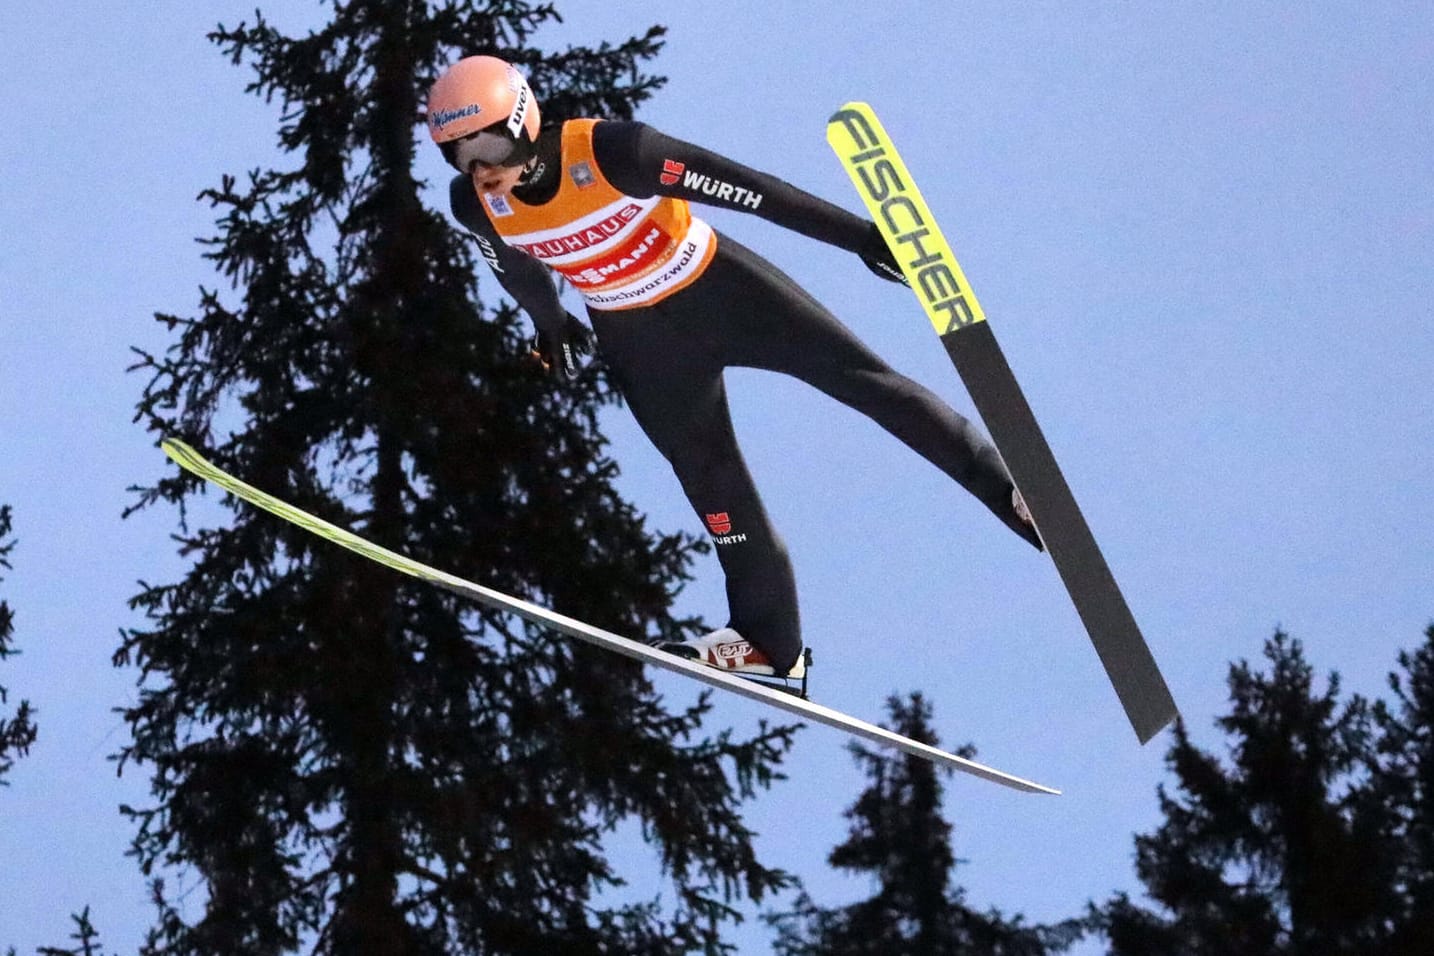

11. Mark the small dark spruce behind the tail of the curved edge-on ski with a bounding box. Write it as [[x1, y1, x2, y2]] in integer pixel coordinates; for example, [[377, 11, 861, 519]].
[[770, 694, 1074, 956]]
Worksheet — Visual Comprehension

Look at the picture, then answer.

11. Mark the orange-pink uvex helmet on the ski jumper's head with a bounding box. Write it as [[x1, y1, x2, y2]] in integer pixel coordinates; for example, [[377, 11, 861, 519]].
[[429, 56, 539, 173]]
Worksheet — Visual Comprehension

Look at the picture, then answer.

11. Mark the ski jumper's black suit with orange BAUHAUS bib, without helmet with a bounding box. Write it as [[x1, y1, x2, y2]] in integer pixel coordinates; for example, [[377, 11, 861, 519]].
[[450, 119, 1012, 674]]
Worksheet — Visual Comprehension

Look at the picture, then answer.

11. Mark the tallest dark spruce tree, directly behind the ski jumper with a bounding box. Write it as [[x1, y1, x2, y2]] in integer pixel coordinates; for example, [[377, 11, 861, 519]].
[[116, 0, 792, 956]]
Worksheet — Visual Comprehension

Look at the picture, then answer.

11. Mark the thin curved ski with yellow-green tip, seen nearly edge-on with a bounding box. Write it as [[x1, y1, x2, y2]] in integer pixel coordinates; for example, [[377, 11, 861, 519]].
[[161, 439, 1060, 794]]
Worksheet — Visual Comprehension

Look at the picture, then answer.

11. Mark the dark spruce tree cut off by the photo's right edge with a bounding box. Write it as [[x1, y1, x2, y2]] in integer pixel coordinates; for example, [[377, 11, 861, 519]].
[[1372, 625, 1434, 956]]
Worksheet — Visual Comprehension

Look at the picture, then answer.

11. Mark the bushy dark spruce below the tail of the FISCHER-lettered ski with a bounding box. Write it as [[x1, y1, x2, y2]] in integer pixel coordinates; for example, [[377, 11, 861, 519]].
[[1093, 632, 1397, 956]]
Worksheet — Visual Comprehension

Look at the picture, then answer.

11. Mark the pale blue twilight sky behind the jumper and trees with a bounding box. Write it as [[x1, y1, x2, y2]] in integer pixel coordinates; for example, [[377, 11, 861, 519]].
[[0, 0, 1434, 953]]
